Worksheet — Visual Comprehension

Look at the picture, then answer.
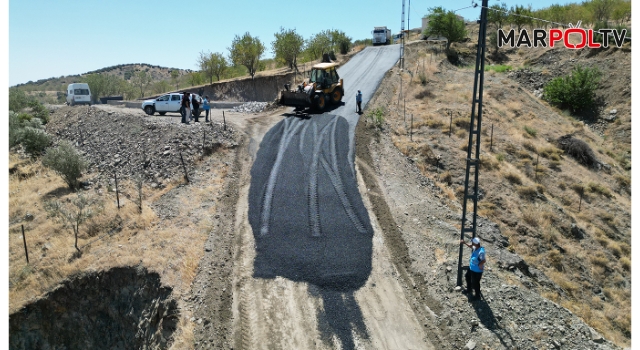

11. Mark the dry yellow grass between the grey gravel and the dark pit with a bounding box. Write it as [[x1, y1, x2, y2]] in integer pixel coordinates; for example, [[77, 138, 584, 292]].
[[9, 150, 232, 342]]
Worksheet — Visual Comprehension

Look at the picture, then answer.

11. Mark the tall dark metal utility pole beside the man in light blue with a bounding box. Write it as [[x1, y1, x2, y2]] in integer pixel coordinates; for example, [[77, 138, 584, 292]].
[[457, 0, 488, 286]]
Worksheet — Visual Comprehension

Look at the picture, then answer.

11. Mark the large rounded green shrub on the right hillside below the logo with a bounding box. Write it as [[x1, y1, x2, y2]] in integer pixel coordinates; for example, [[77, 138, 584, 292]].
[[544, 66, 601, 112]]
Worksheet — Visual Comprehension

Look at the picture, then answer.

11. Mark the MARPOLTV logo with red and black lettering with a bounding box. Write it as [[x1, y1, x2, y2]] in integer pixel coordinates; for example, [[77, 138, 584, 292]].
[[498, 28, 627, 50]]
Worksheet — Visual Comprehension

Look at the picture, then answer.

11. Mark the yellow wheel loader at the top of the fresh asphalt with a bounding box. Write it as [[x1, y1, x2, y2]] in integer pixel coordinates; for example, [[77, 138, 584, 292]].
[[280, 62, 344, 112]]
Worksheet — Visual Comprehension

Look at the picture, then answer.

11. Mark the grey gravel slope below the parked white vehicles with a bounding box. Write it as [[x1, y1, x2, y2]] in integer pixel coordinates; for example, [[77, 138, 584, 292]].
[[46, 107, 237, 187]]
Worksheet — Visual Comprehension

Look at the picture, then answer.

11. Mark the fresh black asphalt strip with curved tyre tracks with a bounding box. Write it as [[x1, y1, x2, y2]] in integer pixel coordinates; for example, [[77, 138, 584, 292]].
[[249, 113, 373, 292]]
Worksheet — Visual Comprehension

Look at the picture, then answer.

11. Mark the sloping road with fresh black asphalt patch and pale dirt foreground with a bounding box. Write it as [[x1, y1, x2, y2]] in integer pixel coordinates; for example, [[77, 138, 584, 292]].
[[188, 47, 440, 349]]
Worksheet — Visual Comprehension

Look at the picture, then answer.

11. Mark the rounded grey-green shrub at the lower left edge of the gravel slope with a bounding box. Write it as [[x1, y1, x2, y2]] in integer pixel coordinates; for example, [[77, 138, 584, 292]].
[[42, 140, 87, 189]]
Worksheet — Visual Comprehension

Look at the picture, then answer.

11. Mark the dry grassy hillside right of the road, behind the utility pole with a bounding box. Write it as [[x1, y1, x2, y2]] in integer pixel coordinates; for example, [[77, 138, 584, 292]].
[[368, 28, 631, 346]]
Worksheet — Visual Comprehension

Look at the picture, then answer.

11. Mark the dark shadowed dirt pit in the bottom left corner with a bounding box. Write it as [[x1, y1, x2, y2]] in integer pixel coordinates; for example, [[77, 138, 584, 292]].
[[9, 267, 179, 349]]
